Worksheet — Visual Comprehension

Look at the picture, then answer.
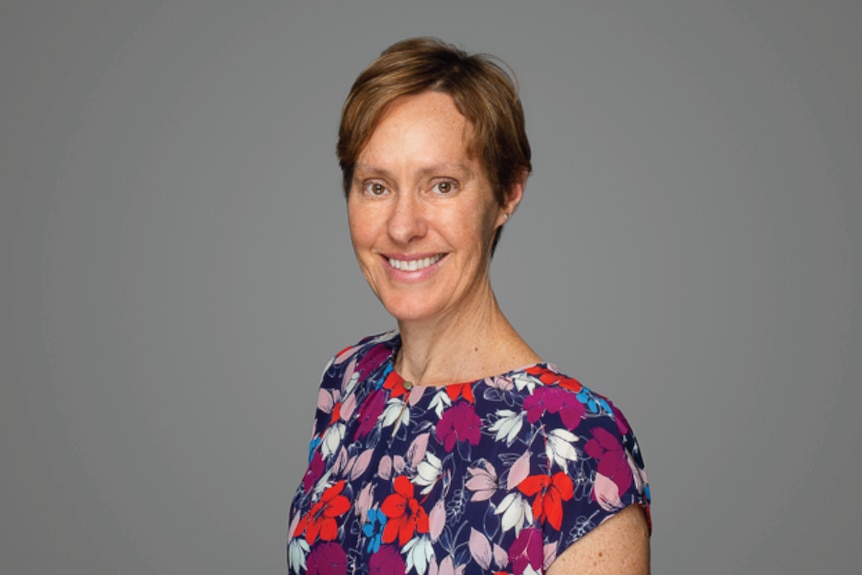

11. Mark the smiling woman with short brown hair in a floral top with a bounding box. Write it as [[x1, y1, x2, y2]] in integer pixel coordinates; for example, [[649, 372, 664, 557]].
[[288, 38, 649, 575]]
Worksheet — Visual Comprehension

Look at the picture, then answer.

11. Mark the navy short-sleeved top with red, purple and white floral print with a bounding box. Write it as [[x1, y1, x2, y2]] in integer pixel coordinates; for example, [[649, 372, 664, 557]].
[[288, 332, 649, 575]]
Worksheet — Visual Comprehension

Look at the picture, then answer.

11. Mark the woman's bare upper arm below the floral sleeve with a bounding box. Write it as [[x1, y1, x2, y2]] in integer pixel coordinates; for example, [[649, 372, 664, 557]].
[[547, 504, 649, 575]]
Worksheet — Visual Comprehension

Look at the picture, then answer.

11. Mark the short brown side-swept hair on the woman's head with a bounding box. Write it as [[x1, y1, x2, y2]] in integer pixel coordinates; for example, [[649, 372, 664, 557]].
[[336, 38, 532, 251]]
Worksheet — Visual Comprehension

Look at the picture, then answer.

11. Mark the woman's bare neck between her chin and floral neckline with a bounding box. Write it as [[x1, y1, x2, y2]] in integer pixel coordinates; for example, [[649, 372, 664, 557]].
[[395, 290, 541, 385]]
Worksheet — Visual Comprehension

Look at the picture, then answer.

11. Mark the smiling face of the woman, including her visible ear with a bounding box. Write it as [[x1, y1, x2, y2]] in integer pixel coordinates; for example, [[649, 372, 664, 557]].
[[347, 92, 522, 321]]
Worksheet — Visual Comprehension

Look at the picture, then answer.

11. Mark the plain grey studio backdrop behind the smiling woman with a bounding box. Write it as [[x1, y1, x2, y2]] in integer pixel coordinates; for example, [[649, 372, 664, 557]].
[[0, 0, 862, 574]]
